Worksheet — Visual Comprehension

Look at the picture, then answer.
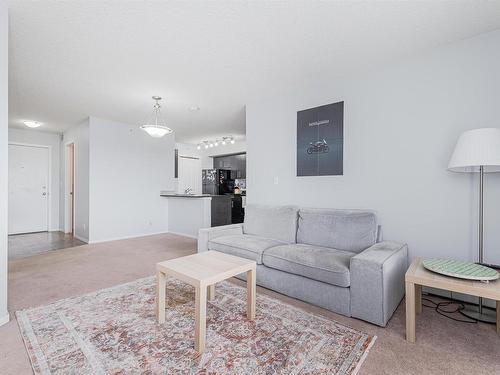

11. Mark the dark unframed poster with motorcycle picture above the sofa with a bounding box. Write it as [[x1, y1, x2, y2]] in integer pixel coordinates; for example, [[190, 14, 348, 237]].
[[297, 102, 344, 176]]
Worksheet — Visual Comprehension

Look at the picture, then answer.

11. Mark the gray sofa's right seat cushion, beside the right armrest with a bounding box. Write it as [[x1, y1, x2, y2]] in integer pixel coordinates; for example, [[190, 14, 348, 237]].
[[262, 244, 356, 288]]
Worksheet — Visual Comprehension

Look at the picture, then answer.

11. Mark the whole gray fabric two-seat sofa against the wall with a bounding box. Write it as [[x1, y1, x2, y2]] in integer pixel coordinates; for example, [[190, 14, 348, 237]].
[[198, 205, 408, 326]]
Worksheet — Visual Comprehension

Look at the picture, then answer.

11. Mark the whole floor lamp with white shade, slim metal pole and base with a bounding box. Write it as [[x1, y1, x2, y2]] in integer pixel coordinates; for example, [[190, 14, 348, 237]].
[[448, 128, 500, 323]]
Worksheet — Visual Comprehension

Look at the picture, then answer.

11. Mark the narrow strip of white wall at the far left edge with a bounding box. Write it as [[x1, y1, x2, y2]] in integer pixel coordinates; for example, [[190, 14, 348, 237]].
[[0, 1, 9, 325]]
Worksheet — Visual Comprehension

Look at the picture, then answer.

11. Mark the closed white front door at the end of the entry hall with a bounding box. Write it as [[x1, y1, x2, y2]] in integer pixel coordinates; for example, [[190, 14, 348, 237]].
[[9, 144, 49, 234]]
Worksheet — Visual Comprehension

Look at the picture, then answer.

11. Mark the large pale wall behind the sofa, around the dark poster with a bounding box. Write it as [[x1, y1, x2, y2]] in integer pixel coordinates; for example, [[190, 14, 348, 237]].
[[246, 31, 500, 264]]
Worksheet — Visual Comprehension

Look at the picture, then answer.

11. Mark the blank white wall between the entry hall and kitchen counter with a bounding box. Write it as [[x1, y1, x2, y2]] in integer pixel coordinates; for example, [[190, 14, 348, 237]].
[[89, 117, 174, 242]]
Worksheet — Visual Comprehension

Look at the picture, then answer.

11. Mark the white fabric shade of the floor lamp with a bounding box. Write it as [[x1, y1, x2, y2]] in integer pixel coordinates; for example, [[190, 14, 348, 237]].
[[448, 128, 500, 172]]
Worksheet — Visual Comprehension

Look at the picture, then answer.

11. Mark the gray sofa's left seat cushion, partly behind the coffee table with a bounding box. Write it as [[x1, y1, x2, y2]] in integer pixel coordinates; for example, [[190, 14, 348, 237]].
[[208, 234, 285, 264]]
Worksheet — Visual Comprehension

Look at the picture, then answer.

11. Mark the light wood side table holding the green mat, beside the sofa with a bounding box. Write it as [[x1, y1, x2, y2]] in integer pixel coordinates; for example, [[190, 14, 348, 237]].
[[405, 258, 500, 342]]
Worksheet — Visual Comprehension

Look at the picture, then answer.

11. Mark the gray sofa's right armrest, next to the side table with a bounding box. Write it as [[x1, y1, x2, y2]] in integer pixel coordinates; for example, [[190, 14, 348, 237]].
[[350, 241, 408, 327]]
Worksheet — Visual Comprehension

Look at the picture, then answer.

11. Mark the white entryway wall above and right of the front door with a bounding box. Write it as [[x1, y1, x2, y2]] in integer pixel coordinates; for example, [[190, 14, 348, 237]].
[[9, 128, 64, 231]]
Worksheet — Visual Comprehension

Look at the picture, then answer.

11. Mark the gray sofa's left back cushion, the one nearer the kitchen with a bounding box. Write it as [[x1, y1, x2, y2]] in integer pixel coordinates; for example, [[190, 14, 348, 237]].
[[243, 204, 299, 243]]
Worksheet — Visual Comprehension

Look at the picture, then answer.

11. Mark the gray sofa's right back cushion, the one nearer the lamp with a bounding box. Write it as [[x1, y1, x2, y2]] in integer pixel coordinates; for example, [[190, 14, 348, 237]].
[[297, 208, 378, 253]]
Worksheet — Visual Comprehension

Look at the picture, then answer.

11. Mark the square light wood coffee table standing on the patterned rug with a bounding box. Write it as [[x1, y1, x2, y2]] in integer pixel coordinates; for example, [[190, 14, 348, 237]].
[[156, 250, 257, 353]]
